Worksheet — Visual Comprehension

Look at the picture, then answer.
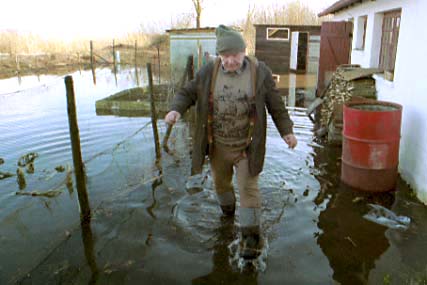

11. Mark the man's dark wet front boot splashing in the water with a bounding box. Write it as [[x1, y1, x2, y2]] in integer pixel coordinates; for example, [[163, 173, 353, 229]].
[[240, 226, 264, 259]]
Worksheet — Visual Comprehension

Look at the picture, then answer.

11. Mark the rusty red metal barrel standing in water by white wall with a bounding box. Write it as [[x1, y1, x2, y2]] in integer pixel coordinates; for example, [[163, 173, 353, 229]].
[[341, 101, 402, 192]]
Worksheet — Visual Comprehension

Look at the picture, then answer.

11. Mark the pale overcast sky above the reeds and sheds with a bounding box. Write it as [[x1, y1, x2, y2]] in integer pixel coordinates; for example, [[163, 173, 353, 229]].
[[0, 0, 336, 40]]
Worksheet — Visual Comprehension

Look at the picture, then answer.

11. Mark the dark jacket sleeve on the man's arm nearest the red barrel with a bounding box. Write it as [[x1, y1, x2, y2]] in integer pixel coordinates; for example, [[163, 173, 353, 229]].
[[263, 65, 293, 137]]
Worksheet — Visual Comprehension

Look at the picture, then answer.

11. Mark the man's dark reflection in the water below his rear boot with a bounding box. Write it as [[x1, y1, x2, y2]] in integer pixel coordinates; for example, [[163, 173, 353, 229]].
[[192, 217, 258, 285]]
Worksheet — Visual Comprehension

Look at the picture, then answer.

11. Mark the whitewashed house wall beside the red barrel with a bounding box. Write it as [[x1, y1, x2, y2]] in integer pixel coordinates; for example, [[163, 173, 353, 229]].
[[334, 0, 427, 204]]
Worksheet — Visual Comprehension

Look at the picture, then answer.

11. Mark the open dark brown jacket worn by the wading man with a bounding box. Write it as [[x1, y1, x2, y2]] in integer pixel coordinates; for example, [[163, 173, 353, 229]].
[[171, 56, 293, 176]]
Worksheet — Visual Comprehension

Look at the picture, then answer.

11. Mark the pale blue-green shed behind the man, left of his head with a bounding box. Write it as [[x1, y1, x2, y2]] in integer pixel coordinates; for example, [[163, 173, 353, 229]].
[[166, 27, 216, 82]]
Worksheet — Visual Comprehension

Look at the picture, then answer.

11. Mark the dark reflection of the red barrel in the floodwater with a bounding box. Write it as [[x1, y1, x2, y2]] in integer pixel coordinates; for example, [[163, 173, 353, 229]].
[[315, 141, 394, 284]]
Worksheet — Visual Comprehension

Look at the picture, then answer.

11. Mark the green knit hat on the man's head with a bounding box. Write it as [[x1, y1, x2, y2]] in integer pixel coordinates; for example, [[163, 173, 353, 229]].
[[215, 25, 246, 54]]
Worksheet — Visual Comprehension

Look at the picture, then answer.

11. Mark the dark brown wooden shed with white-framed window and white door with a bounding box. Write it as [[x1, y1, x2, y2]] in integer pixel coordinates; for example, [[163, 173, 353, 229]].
[[255, 24, 320, 74]]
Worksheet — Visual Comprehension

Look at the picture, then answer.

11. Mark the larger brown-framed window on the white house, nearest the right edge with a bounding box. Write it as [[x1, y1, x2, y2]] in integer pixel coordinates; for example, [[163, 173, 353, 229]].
[[379, 10, 401, 79]]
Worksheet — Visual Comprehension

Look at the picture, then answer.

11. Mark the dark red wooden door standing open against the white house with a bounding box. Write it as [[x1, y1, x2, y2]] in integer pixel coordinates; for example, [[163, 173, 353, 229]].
[[317, 22, 353, 96]]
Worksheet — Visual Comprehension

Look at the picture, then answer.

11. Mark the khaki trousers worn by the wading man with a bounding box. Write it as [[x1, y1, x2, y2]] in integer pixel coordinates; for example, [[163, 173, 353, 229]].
[[210, 144, 261, 206]]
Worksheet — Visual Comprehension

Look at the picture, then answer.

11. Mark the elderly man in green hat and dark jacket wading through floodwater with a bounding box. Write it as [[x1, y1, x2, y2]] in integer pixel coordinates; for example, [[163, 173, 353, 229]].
[[165, 25, 297, 259]]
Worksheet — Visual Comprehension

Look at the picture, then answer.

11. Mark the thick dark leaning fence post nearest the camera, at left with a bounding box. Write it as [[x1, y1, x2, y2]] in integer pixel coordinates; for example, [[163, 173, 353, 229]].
[[65, 76, 90, 219]]
